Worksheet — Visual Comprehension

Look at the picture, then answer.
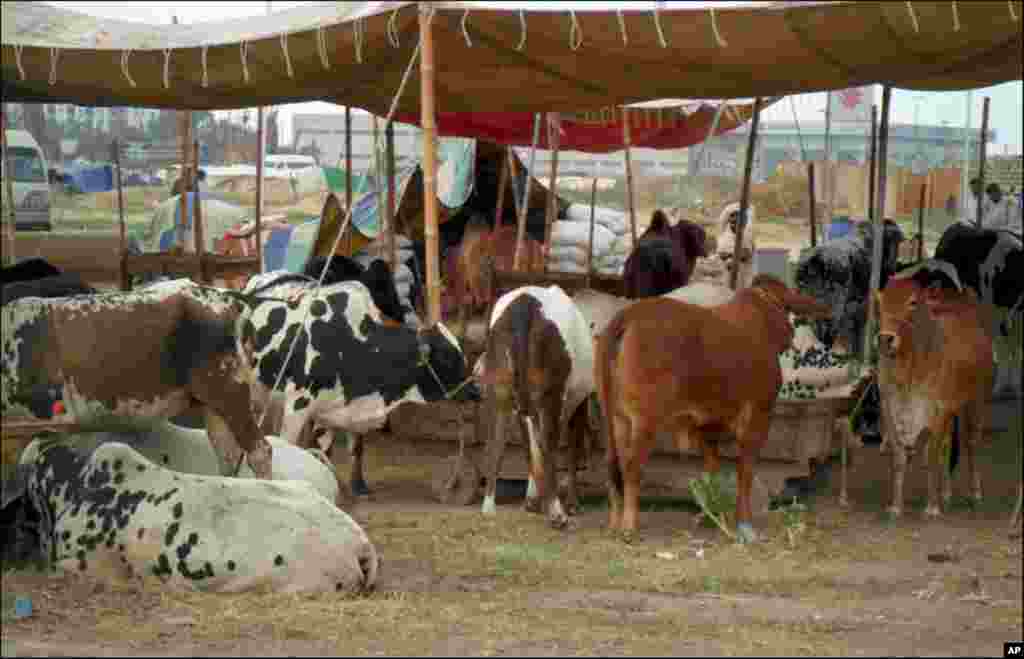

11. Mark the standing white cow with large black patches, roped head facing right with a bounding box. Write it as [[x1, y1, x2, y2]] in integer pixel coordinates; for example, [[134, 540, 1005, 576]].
[[241, 275, 479, 494]]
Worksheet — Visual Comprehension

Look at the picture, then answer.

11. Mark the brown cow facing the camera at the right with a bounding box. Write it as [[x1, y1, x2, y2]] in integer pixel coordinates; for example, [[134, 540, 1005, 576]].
[[876, 259, 994, 517]]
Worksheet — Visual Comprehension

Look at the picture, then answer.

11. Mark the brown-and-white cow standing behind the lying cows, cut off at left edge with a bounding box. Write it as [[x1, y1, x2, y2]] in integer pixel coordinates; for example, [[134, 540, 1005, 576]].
[[0, 279, 271, 478]]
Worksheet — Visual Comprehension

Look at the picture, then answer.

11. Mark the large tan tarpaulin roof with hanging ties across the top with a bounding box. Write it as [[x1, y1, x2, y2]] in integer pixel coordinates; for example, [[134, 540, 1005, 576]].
[[2, 0, 1024, 115]]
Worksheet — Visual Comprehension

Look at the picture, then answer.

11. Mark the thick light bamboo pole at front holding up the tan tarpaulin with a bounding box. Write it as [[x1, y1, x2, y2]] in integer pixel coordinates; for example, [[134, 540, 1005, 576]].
[[419, 2, 441, 324]]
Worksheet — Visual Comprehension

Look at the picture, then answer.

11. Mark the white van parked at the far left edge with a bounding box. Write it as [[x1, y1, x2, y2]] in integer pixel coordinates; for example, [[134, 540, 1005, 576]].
[[0, 130, 53, 231]]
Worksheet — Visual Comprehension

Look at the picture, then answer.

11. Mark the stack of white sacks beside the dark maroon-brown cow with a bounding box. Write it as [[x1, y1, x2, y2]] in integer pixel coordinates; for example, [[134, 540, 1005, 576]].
[[548, 204, 630, 274]]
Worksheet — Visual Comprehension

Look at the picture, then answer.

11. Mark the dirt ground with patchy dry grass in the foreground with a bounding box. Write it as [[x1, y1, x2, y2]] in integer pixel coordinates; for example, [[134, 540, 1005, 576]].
[[2, 421, 1024, 657]]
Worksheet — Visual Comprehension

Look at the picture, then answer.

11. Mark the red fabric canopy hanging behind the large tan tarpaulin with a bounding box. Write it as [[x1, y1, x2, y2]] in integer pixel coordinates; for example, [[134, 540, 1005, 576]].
[[387, 100, 775, 153]]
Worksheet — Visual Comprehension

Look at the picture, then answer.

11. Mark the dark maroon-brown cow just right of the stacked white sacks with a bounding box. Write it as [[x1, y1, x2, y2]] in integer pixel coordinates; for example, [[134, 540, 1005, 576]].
[[623, 210, 711, 299]]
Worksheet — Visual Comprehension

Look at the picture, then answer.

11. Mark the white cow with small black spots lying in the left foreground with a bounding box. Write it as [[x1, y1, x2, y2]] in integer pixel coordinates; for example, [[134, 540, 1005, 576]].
[[14, 440, 379, 592]]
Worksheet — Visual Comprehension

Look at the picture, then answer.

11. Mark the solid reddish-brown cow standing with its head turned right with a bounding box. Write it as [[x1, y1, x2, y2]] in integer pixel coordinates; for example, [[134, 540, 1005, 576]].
[[595, 274, 829, 541]]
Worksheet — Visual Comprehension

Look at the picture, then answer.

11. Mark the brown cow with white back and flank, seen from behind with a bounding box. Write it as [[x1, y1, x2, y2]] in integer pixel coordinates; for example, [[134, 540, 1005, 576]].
[[479, 285, 594, 528]]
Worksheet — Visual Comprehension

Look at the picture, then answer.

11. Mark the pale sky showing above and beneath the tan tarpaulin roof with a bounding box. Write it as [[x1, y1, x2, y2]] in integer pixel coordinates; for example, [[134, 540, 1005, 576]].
[[47, 0, 1024, 153]]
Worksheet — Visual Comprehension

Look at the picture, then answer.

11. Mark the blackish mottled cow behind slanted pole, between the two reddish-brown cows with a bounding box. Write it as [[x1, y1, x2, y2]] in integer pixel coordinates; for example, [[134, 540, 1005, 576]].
[[795, 220, 903, 357]]
